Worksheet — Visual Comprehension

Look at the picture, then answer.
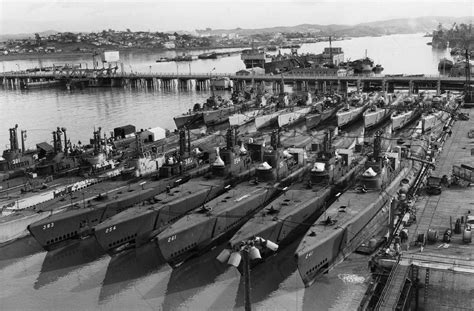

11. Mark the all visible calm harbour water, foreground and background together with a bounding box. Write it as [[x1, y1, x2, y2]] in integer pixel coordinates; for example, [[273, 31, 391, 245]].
[[0, 34, 447, 310]]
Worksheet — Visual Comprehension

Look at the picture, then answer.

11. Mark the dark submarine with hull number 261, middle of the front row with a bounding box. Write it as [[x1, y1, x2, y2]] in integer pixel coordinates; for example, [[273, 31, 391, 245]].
[[156, 133, 307, 267]]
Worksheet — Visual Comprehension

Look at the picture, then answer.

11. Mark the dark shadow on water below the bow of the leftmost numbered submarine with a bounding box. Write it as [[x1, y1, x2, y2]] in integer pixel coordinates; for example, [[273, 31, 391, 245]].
[[33, 238, 105, 289]]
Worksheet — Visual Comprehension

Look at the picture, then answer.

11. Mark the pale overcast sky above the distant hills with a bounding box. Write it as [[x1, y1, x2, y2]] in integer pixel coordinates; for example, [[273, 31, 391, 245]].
[[0, 0, 474, 34]]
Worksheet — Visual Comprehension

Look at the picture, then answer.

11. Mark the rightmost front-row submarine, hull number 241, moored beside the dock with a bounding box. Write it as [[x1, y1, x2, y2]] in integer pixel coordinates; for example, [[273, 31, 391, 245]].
[[295, 133, 421, 286]]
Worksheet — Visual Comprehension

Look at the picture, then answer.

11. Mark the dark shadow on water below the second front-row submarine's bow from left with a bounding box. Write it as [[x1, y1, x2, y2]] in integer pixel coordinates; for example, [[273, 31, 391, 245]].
[[99, 243, 168, 304]]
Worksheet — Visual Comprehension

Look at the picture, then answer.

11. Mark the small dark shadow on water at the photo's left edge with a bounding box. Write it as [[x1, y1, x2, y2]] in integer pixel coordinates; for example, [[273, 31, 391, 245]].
[[0, 235, 43, 270]]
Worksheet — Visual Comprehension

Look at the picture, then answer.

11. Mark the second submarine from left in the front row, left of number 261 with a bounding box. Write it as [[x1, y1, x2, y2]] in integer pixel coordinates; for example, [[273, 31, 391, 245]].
[[94, 130, 256, 253]]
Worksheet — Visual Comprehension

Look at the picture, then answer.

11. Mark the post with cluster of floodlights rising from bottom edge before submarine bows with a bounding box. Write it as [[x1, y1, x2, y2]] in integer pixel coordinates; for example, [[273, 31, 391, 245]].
[[217, 237, 278, 311]]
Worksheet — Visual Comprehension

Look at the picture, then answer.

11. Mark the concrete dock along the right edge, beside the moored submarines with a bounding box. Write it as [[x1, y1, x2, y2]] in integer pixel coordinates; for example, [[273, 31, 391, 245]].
[[377, 109, 474, 310]]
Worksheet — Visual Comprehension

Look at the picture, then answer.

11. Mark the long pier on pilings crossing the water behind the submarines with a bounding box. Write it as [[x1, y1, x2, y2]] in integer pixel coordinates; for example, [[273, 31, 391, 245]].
[[1, 68, 473, 93]]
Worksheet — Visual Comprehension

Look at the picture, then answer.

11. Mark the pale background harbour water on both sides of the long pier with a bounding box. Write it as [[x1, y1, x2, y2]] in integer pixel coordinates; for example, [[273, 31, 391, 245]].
[[0, 34, 449, 149]]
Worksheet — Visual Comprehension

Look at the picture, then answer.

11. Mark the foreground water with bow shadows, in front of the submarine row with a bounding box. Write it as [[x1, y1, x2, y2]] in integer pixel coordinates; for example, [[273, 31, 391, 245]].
[[0, 238, 369, 310]]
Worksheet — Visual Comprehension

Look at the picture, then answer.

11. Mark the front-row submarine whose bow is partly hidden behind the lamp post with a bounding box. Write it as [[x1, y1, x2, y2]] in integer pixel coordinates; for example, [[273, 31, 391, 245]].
[[219, 132, 366, 265]]
